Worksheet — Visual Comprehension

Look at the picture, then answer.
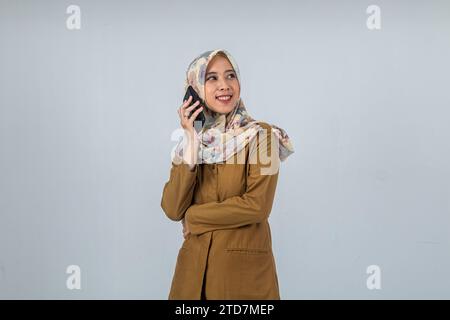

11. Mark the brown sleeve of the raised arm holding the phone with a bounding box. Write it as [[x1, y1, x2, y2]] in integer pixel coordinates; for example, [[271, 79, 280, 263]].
[[161, 161, 198, 221]]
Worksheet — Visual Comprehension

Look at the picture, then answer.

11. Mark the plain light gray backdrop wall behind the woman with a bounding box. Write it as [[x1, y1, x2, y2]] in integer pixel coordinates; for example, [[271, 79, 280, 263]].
[[0, 0, 450, 299]]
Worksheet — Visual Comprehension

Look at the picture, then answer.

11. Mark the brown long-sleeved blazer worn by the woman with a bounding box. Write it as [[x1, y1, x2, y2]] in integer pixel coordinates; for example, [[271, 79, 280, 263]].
[[161, 123, 280, 300]]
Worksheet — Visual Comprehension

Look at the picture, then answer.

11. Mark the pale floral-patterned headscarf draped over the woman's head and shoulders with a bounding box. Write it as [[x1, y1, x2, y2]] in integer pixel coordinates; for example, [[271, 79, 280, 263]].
[[175, 49, 294, 163]]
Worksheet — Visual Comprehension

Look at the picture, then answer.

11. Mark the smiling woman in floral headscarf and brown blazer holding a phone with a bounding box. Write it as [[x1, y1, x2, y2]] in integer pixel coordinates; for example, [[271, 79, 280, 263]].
[[161, 49, 293, 300]]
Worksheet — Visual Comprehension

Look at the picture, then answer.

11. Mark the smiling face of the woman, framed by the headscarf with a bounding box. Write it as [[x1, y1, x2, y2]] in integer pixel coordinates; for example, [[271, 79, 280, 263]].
[[205, 55, 240, 114]]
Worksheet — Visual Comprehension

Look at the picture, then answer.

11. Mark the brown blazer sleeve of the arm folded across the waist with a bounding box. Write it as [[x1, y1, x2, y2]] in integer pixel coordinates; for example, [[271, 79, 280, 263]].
[[185, 127, 279, 235]]
